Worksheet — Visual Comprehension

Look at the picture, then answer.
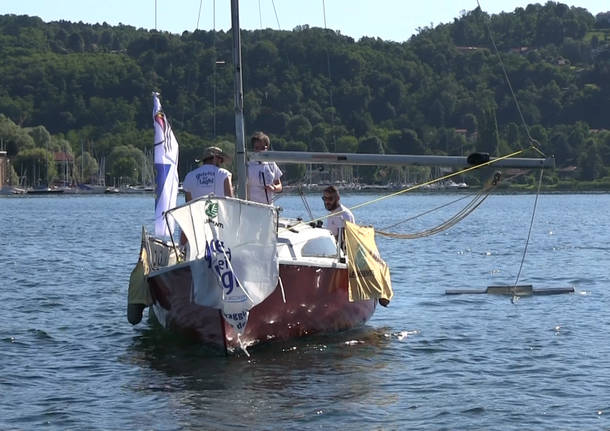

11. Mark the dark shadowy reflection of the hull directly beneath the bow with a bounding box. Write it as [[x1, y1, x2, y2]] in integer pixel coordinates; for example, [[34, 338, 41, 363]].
[[128, 325, 394, 382]]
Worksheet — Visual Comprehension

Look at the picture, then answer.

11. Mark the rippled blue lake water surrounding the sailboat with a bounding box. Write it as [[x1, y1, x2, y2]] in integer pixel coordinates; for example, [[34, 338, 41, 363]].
[[0, 194, 610, 430]]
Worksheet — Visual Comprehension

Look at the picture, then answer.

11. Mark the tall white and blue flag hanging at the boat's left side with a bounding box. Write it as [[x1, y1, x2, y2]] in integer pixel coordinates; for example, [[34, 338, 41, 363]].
[[153, 92, 178, 236]]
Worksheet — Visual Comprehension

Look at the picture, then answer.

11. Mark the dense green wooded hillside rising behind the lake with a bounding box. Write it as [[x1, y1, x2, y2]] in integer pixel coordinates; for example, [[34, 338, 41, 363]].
[[0, 2, 610, 186]]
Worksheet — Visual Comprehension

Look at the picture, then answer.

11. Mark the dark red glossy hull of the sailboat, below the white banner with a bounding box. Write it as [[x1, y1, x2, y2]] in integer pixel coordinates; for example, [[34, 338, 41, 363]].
[[148, 265, 376, 351]]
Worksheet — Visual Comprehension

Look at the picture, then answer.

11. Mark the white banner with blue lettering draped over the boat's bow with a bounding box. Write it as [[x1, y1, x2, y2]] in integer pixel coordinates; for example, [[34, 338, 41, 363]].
[[170, 197, 279, 334]]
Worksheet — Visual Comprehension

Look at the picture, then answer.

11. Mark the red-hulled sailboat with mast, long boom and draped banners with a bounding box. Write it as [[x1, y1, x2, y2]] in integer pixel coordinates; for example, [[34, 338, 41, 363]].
[[127, 0, 552, 353]]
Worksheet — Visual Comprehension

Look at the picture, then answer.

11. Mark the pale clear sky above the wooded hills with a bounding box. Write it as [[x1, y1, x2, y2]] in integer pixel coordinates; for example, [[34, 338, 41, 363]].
[[0, 0, 610, 42]]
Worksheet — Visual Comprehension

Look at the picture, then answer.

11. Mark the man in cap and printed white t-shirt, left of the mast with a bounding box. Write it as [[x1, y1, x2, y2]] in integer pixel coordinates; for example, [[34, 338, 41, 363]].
[[182, 147, 233, 202]]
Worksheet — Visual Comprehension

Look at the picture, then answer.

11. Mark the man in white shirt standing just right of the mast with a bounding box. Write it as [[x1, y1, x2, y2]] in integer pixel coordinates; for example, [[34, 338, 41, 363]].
[[248, 132, 283, 204]]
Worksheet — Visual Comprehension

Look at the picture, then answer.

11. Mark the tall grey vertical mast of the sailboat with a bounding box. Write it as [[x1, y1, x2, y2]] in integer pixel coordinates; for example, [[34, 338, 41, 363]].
[[231, 0, 246, 199]]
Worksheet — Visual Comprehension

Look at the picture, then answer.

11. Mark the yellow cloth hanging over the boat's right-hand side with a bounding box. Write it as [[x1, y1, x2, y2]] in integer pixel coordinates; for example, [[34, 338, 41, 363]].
[[345, 221, 394, 301]]
